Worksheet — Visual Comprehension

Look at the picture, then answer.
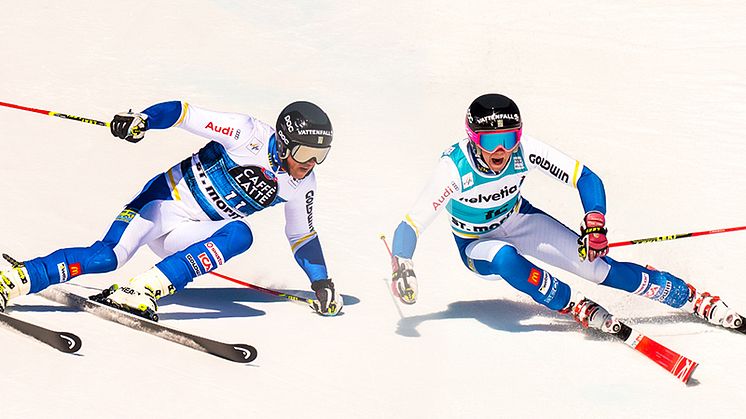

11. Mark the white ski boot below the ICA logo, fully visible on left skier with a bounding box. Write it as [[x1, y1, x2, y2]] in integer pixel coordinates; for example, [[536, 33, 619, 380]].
[[89, 268, 176, 322]]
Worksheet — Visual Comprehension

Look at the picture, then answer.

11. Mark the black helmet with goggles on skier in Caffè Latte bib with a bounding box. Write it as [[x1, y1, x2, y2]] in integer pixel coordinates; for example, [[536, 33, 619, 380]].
[[275, 101, 334, 163]]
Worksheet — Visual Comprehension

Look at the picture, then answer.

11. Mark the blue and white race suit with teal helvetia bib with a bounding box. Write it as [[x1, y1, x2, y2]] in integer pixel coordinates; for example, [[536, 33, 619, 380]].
[[393, 135, 688, 310]]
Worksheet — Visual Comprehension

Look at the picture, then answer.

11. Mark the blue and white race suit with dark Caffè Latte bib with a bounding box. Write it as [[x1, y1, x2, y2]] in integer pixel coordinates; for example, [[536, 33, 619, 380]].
[[25, 101, 328, 292]]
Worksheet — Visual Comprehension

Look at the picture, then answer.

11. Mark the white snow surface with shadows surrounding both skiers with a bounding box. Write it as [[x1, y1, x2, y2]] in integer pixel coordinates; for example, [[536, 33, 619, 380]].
[[0, 0, 746, 418]]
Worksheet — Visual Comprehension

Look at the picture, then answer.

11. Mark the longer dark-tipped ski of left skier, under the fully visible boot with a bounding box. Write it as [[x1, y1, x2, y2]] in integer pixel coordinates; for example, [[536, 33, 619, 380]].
[[39, 288, 257, 364]]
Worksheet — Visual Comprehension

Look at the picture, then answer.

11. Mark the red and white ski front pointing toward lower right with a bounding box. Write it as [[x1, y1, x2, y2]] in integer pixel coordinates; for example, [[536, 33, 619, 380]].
[[612, 322, 699, 384]]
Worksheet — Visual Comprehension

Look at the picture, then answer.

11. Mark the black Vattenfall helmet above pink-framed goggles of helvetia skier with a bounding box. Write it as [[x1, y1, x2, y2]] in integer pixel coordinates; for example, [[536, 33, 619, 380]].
[[466, 93, 523, 139]]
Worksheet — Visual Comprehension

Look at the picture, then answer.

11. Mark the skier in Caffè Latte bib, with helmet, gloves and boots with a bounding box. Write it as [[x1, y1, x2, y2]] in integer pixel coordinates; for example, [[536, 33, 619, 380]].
[[0, 101, 343, 319]]
